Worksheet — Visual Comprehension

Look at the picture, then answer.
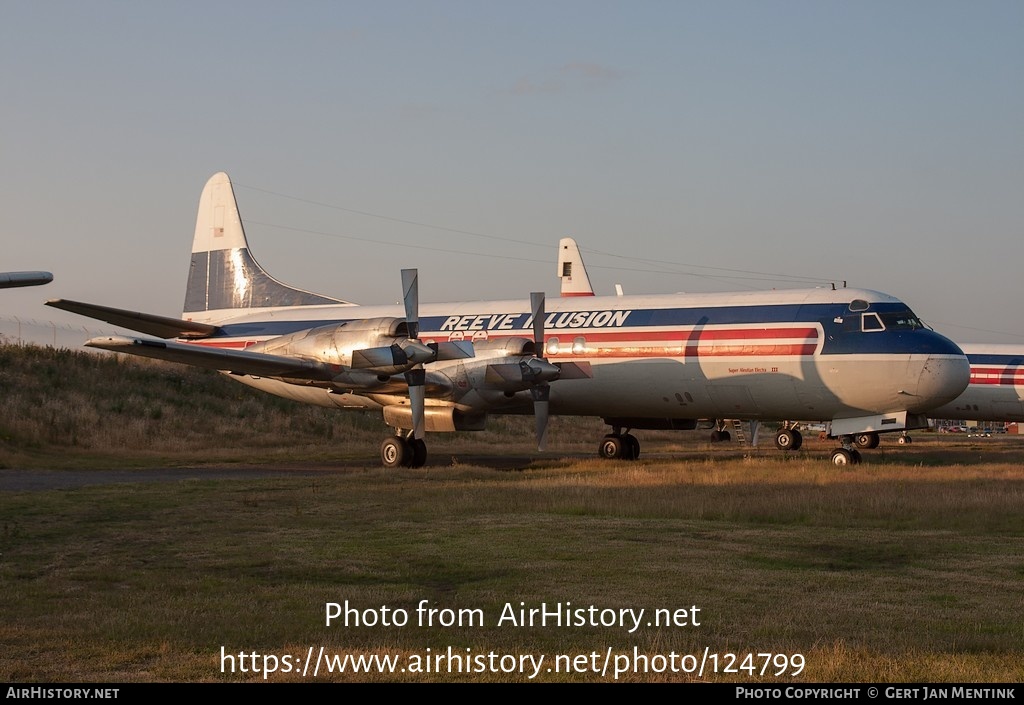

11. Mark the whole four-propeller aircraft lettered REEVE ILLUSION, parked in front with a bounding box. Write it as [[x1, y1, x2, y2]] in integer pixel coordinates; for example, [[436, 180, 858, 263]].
[[47, 173, 969, 467]]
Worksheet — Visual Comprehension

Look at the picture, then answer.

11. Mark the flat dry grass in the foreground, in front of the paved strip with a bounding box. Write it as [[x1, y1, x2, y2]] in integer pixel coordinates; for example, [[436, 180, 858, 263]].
[[0, 450, 1024, 682]]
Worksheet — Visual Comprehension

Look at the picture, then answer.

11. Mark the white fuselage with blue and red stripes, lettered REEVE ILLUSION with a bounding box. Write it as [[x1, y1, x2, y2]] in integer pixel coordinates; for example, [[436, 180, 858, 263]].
[[193, 289, 969, 420]]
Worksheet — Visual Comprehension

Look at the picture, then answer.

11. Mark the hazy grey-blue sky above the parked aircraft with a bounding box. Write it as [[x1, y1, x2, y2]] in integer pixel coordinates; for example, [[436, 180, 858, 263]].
[[0, 0, 1024, 343]]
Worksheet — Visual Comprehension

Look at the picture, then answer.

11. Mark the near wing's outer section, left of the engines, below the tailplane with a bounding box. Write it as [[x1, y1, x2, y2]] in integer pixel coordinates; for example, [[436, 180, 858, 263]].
[[85, 335, 339, 381]]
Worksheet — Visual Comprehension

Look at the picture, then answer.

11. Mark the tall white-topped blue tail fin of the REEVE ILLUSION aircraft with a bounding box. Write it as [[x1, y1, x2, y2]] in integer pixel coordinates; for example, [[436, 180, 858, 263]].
[[183, 171, 349, 323]]
